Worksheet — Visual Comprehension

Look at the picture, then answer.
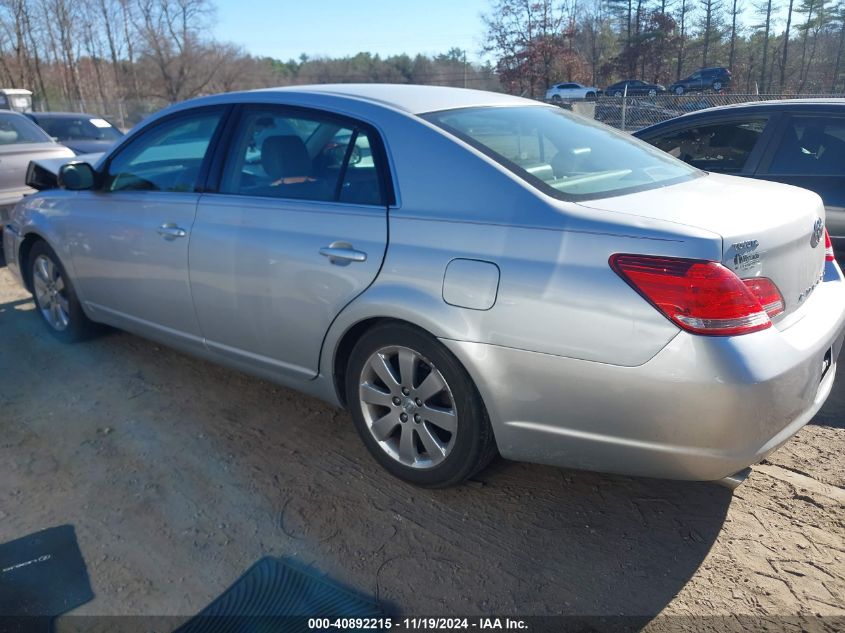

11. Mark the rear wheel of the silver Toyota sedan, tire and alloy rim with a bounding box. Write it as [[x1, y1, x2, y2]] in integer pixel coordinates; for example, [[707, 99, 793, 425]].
[[346, 323, 496, 488]]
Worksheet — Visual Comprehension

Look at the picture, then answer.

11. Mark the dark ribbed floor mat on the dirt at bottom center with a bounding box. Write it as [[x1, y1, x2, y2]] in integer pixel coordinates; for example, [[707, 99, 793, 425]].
[[174, 557, 386, 633]]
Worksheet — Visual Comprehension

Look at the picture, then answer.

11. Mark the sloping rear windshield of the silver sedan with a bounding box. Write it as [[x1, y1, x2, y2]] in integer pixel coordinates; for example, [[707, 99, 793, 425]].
[[423, 106, 702, 200]]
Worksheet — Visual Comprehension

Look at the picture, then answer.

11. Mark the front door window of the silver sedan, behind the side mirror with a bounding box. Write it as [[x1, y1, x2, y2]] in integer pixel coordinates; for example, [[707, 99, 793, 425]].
[[103, 108, 222, 192]]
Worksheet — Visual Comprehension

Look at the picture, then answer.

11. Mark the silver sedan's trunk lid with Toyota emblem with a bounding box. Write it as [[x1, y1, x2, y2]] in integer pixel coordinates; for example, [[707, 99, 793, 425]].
[[581, 174, 825, 322]]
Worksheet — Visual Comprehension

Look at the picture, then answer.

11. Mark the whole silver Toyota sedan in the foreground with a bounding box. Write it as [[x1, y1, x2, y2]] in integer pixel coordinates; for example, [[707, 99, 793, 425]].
[[4, 85, 845, 486]]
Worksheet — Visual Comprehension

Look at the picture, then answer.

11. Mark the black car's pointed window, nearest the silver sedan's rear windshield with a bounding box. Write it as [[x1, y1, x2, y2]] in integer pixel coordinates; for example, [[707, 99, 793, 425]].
[[648, 118, 767, 174]]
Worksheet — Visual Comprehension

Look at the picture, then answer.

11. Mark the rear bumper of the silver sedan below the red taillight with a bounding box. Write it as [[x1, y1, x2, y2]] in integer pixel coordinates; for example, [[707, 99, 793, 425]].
[[443, 266, 845, 480]]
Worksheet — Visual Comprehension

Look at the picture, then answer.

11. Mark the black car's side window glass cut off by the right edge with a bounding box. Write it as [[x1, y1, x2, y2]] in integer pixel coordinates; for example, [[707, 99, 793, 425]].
[[767, 117, 845, 176]]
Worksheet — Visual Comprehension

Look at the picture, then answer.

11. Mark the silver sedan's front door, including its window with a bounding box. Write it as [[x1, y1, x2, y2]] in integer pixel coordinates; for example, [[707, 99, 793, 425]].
[[68, 107, 225, 347]]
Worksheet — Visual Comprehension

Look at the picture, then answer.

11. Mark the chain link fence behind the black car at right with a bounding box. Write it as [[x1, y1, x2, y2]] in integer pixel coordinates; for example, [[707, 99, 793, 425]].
[[559, 93, 842, 132]]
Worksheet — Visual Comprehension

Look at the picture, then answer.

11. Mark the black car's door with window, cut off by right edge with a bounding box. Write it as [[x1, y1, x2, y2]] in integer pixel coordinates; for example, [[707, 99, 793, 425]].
[[756, 111, 845, 252]]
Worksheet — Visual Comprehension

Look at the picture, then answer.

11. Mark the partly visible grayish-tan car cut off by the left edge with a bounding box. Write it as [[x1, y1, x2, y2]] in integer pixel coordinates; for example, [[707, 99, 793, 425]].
[[0, 110, 73, 231]]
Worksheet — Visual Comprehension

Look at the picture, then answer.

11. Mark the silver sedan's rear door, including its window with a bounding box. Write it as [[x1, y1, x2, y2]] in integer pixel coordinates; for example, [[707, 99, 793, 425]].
[[189, 105, 389, 378]]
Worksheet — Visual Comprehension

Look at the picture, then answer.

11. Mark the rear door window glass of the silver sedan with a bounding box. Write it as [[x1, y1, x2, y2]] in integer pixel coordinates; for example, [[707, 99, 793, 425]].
[[220, 106, 384, 205]]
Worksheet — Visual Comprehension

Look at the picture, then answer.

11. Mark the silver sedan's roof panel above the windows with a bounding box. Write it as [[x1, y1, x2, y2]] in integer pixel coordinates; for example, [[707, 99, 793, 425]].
[[192, 84, 547, 114]]
